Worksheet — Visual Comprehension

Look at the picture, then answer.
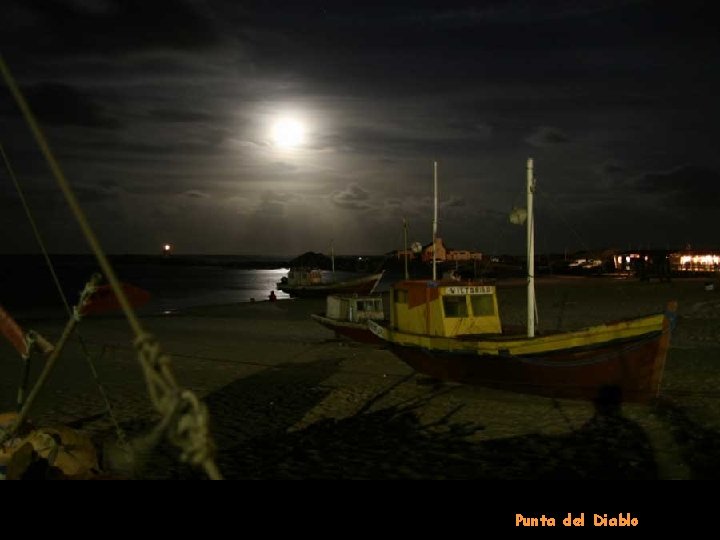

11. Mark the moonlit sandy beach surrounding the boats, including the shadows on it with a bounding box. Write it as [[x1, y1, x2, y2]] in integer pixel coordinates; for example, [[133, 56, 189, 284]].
[[0, 277, 720, 480]]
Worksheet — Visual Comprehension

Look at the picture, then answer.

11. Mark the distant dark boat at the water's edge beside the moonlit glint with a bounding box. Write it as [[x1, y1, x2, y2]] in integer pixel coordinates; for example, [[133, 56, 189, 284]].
[[277, 269, 383, 297]]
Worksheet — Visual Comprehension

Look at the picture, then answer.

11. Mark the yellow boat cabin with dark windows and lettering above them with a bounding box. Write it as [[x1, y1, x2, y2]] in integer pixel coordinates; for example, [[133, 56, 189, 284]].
[[390, 280, 502, 337]]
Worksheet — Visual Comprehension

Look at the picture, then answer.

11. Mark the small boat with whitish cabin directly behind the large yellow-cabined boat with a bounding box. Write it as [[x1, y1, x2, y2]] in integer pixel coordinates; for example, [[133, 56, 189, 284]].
[[310, 294, 385, 345]]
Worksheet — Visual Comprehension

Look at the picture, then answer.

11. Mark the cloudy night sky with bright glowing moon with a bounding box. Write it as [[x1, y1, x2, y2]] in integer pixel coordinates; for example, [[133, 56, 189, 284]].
[[0, 0, 720, 255]]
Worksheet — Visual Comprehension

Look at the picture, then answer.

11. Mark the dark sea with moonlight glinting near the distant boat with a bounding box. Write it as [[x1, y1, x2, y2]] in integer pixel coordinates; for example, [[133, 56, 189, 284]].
[[0, 254, 296, 318]]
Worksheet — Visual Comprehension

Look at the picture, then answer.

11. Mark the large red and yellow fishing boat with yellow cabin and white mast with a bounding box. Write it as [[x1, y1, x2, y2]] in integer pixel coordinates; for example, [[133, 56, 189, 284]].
[[368, 159, 677, 402]]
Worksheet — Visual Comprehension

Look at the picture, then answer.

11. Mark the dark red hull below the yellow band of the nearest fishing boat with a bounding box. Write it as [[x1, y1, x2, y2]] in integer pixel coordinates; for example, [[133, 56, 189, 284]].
[[371, 306, 674, 402]]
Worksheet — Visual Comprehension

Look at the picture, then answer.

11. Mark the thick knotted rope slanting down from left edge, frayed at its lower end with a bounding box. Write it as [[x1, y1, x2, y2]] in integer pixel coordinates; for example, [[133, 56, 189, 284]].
[[0, 56, 221, 479]]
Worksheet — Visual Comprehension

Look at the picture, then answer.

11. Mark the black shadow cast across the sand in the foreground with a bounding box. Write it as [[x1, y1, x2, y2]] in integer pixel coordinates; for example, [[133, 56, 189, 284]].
[[101, 359, 720, 480]]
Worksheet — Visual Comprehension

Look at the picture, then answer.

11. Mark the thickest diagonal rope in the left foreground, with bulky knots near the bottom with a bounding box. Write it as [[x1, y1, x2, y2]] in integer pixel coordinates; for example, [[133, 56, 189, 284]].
[[0, 55, 222, 479]]
